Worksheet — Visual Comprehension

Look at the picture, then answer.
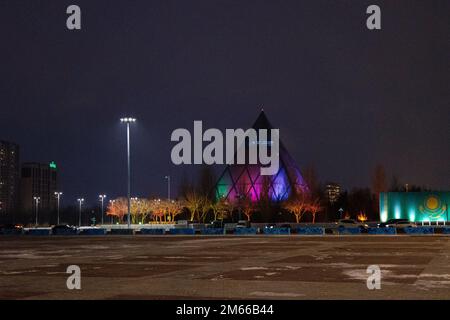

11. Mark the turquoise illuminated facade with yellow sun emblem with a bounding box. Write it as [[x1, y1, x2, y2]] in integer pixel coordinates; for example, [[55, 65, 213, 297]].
[[380, 191, 450, 222]]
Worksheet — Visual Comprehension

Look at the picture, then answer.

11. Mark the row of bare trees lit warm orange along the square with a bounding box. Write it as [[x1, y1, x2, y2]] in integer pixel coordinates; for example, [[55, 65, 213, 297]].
[[107, 167, 323, 223]]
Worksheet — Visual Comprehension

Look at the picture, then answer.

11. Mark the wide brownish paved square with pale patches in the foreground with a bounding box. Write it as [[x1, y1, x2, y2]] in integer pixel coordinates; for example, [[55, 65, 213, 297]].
[[0, 235, 450, 299]]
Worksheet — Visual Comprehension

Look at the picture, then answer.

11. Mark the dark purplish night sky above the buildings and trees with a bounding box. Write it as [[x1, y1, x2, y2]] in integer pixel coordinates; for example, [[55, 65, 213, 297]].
[[0, 0, 450, 204]]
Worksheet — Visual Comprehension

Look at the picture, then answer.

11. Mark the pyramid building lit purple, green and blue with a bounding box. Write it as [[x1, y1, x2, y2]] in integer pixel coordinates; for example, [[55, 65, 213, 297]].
[[215, 111, 309, 203]]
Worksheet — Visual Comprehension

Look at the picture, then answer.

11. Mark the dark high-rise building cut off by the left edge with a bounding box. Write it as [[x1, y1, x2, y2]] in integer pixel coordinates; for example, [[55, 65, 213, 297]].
[[0, 140, 19, 216]]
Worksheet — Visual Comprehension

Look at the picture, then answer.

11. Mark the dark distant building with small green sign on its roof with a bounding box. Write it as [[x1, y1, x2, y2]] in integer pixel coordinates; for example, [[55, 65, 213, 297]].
[[20, 162, 58, 213]]
